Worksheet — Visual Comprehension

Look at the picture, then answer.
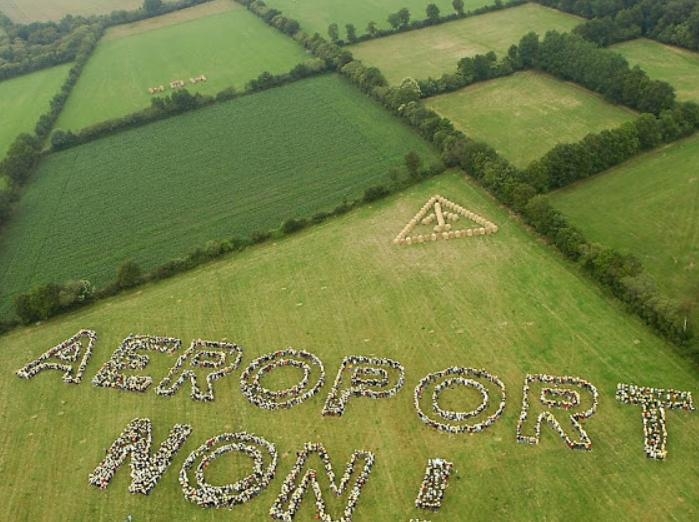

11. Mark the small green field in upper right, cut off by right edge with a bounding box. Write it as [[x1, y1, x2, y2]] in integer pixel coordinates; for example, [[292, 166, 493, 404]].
[[611, 38, 699, 102]]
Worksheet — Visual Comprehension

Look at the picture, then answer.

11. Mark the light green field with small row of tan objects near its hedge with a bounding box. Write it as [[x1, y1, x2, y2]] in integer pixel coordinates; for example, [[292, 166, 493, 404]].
[[58, 0, 308, 129]]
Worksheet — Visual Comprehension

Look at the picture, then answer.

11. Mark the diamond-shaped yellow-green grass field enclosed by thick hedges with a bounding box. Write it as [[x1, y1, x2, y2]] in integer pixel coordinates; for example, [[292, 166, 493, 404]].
[[425, 72, 634, 167]]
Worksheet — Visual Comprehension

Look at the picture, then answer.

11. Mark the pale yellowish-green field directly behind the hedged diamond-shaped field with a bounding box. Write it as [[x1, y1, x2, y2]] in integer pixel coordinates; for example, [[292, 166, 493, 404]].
[[350, 4, 580, 83]]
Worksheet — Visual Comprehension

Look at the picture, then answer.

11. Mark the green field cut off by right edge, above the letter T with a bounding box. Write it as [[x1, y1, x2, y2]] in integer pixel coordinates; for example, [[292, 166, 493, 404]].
[[553, 132, 699, 325]]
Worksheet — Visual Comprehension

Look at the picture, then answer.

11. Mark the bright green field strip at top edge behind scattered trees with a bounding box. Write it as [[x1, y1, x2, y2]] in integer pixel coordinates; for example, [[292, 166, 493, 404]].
[[266, 0, 494, 38]]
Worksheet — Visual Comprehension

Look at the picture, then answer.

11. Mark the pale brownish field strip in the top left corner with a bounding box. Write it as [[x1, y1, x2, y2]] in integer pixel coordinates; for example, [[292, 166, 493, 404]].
[[0, 0, 151, 24]]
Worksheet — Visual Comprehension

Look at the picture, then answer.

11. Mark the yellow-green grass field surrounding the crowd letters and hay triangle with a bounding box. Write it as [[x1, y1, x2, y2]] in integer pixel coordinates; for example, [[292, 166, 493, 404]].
[[0, 174, 699, 522]]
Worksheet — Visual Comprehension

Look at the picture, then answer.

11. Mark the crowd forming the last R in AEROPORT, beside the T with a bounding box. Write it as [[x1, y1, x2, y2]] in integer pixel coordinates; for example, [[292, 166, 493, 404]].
[[516, 374, 599, 451]]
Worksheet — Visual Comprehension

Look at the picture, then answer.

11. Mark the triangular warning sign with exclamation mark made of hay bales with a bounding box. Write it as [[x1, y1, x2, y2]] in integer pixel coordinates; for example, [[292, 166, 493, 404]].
[[393, 195, 498, 245]]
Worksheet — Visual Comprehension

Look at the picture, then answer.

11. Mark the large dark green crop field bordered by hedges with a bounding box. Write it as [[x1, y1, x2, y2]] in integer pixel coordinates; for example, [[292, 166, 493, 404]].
[[0, 76, 434, 311]]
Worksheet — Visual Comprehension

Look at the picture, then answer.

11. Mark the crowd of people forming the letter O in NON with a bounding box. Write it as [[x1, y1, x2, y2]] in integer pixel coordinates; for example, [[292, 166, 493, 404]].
[[179, 432, 279, 508]]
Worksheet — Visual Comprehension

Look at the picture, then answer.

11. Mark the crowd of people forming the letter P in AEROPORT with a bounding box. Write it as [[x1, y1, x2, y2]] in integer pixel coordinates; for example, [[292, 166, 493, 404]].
[[322, 355, 405, 417]]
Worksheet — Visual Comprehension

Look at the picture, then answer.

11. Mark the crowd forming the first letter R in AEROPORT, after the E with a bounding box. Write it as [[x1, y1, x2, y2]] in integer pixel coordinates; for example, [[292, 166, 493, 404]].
[[155, 339, 243, 402]]
